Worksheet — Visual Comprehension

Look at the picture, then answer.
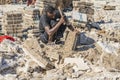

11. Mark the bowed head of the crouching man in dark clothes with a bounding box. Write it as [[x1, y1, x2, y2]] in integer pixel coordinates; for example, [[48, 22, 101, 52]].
[[45, 5, 55, 18]]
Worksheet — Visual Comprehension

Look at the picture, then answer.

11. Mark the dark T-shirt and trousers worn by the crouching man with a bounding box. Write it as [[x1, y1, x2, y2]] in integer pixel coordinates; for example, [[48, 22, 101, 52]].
[[39, 11, 66, 43]]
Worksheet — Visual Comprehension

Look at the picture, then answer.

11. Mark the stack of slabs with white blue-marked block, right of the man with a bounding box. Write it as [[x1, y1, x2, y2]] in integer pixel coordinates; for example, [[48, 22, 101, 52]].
[[72, 0, 94, 27]]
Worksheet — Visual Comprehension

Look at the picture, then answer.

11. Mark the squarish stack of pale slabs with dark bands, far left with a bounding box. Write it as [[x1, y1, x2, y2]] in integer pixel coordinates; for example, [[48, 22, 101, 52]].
[[2, 11, 23, 37]]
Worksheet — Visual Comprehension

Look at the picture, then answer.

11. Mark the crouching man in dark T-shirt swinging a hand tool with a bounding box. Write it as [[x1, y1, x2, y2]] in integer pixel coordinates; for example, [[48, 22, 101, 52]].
[[39, 5, 77, 44]]
